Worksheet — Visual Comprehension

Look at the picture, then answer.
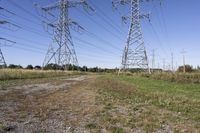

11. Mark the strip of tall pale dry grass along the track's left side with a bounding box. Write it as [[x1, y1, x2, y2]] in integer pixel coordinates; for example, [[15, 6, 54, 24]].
[[0, 69, 86, 89]]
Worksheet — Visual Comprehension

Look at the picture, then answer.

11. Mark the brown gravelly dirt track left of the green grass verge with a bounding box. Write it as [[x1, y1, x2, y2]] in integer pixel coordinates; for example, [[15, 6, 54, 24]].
[[0, 75, 97, 133]]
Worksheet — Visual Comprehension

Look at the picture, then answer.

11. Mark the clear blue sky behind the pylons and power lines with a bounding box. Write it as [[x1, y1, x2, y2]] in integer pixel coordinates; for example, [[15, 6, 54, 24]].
[[0, 0, 200, 68]]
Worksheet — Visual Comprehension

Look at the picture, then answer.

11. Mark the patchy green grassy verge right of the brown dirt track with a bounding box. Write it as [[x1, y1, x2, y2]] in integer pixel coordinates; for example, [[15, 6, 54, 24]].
[[92, 76, 200, 133]]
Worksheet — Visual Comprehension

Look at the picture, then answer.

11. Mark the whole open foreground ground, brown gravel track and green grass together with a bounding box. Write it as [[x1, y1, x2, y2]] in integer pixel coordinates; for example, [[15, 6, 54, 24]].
[[0, 71, 200, 133]]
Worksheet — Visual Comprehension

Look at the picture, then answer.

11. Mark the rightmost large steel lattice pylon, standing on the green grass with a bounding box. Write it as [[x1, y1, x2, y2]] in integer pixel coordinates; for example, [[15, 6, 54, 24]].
[[113, 0, 150, 73]]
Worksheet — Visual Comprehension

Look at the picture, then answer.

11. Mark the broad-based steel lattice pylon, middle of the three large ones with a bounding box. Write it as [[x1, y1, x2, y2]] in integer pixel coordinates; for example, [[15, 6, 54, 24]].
[[38, 0, 93, 67]]
